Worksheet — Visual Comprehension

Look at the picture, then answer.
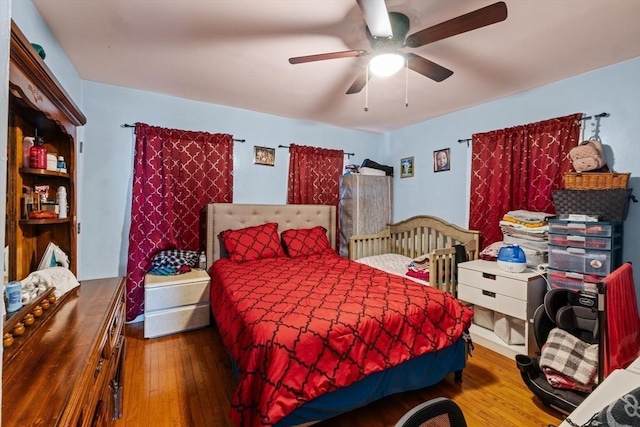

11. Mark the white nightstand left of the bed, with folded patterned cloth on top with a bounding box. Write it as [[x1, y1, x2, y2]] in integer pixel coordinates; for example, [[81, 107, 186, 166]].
[[144, 269, 211, 338]]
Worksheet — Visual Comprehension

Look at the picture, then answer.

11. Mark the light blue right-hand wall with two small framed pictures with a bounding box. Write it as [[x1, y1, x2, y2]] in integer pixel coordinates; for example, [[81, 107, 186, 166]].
[[381, 58, 640, 303]]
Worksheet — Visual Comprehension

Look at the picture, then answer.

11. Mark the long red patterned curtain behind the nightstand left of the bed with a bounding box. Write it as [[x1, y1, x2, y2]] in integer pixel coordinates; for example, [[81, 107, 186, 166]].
[[126, 123, 233, 320]]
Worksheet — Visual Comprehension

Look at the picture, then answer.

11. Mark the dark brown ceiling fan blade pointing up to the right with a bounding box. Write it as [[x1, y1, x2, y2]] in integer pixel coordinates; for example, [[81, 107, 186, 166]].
[[406, 1, 507, 47]]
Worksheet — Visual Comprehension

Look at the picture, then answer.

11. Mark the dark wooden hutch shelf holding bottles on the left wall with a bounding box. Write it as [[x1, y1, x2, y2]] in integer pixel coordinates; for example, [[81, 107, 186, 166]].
[[5, 21, 87, 281]]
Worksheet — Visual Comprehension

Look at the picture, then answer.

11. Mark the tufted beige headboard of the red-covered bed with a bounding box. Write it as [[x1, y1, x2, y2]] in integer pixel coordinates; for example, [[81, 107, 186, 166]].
[[204, 203, 336, 269]]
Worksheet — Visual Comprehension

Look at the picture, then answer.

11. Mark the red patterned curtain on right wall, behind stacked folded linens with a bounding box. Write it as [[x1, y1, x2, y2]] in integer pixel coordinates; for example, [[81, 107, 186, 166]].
[[469, 113, 582, 247]]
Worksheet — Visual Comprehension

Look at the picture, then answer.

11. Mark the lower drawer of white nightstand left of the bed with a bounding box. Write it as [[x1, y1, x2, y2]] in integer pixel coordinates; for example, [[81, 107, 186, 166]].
[[144, 302, 210, 338]]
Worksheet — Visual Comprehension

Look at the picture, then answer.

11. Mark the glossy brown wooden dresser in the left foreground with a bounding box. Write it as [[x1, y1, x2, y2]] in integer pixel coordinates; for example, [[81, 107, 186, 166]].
[[2, 278, 125, 427]]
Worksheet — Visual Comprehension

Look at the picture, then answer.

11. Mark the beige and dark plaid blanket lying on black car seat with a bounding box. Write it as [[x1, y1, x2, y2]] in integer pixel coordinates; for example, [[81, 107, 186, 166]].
[[540, 328, 598, 385]]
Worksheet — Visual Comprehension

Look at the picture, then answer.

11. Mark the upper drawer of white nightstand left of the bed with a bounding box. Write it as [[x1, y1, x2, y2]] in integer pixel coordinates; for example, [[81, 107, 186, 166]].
[[144, 280, 209, 311]]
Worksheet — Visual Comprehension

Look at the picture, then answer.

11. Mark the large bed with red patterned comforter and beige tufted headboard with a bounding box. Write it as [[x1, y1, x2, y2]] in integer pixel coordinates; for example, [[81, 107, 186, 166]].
[[204, 204, 473, 427]]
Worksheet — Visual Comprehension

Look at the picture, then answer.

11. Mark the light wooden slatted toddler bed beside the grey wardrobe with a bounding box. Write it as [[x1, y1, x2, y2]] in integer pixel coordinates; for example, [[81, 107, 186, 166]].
[[349, 215, 480, 295]]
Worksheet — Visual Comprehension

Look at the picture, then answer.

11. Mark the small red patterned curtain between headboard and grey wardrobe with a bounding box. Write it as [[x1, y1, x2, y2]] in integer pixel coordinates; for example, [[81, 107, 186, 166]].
[[287, 144, 344, 242]]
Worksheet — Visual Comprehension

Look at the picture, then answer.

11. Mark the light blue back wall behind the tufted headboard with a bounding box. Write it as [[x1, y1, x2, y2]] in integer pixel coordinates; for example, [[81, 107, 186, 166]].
[[78, 81, 378, 279]]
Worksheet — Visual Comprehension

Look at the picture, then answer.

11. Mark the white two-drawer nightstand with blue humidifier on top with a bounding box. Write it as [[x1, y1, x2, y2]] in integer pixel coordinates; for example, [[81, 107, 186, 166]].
[[458, 260, 546, 359]]
